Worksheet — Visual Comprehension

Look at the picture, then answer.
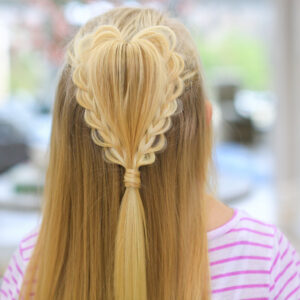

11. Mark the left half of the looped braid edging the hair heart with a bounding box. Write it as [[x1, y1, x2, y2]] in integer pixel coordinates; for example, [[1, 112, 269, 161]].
[[69, 26, 126, 167]]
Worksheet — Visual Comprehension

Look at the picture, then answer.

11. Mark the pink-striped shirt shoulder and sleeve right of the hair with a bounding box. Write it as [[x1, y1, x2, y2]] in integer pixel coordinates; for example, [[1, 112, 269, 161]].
[[208, 210, 300, 299]]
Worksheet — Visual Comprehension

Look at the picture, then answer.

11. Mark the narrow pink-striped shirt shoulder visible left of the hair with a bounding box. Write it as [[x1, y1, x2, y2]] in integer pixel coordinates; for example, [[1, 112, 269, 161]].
[[0, 227, 39, 300]]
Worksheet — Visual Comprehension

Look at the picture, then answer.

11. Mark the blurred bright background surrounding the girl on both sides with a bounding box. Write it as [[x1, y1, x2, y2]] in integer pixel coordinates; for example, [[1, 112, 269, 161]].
[[0, 0, 300, 277]]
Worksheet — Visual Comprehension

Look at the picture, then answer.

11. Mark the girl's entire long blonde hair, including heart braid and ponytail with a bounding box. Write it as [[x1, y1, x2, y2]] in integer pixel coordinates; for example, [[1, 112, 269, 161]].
[[21, 8, 212, 300]]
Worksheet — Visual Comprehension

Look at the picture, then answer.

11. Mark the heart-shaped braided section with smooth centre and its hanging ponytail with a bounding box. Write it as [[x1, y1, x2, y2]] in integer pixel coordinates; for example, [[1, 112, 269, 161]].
[[69, 25, 184, 300]]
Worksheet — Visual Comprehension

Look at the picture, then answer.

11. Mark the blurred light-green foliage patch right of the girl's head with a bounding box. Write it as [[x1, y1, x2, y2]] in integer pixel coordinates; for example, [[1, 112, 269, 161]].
[[196, 30, 270, 90]]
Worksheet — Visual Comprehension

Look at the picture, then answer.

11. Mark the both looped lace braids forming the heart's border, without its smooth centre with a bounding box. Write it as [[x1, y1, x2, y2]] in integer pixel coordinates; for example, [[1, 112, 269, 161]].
[[69, 26, 184, 173]]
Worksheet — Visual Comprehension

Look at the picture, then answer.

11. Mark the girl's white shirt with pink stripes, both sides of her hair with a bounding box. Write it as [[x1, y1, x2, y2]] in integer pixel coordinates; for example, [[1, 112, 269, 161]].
[[0, 210, 300, 300]]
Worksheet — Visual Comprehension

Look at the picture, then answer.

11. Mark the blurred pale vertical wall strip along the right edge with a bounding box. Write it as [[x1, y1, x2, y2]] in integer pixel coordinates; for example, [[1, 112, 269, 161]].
[[274, 0, 300, 237]]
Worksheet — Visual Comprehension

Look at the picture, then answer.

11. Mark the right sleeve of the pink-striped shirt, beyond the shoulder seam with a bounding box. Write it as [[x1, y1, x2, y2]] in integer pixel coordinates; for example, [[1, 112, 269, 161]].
[[270, 228, 300, 300]]
